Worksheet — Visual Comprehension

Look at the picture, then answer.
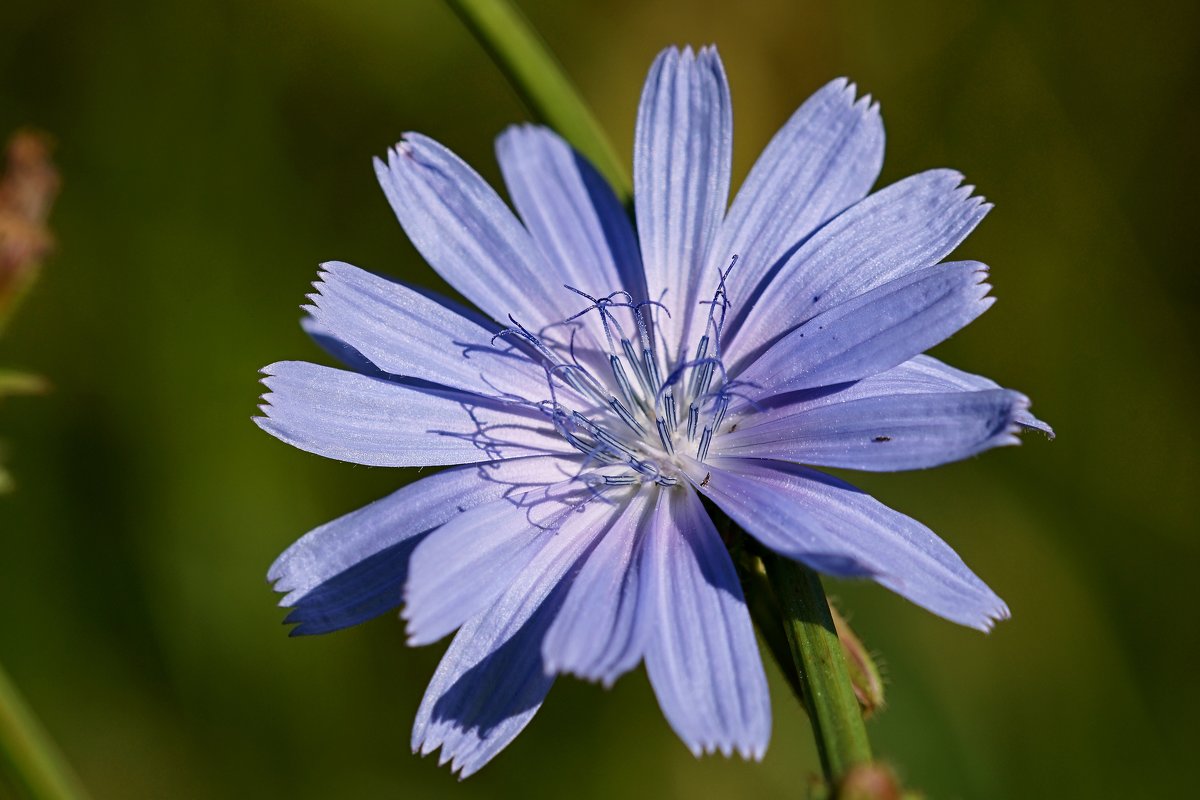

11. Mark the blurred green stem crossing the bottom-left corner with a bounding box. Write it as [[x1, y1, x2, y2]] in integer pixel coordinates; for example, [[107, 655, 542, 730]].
[[0, 667, 88, 800]]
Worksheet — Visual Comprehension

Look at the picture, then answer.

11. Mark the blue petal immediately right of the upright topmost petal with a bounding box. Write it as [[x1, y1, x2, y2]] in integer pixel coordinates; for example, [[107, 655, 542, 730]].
[[688, 78, 883, 352]]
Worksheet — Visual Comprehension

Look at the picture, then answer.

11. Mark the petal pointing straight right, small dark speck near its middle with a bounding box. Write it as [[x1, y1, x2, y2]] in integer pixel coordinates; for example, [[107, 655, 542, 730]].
[[713, 389, 1030, 473]]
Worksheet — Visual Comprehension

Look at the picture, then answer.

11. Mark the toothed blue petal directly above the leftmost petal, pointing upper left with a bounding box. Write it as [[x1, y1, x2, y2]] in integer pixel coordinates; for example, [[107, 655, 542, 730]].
[[308, 261, 546, 397]]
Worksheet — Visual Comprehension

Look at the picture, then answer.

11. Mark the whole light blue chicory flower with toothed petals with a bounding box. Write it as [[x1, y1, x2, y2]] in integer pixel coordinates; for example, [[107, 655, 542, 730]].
[[257, 48, 1049, 776]]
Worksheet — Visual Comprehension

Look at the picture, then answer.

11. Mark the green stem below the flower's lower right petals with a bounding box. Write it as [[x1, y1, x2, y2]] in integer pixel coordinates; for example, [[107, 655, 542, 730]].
[[763, 554, 871, 786]]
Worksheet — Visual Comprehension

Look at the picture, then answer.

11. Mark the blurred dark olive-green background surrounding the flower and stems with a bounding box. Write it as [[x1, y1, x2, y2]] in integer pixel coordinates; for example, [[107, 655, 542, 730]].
[[0, 0, 1200, 799]]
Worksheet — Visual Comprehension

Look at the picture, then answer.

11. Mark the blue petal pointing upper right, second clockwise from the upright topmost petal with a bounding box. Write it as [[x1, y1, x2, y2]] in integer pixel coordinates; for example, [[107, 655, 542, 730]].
[[726, 169, 991, 363]]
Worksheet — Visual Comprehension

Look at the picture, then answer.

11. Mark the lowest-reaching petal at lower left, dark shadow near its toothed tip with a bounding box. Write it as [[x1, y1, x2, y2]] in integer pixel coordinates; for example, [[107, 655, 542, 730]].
[[413, 489, 612, 777]]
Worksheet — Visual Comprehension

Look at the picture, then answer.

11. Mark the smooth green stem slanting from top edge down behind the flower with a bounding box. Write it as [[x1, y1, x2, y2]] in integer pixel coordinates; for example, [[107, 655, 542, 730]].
[[445, 0, 632, 204]]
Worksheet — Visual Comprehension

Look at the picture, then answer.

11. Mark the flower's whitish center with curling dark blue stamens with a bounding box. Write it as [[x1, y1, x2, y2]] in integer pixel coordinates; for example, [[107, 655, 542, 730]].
[[497, 255, 737, 487]]
